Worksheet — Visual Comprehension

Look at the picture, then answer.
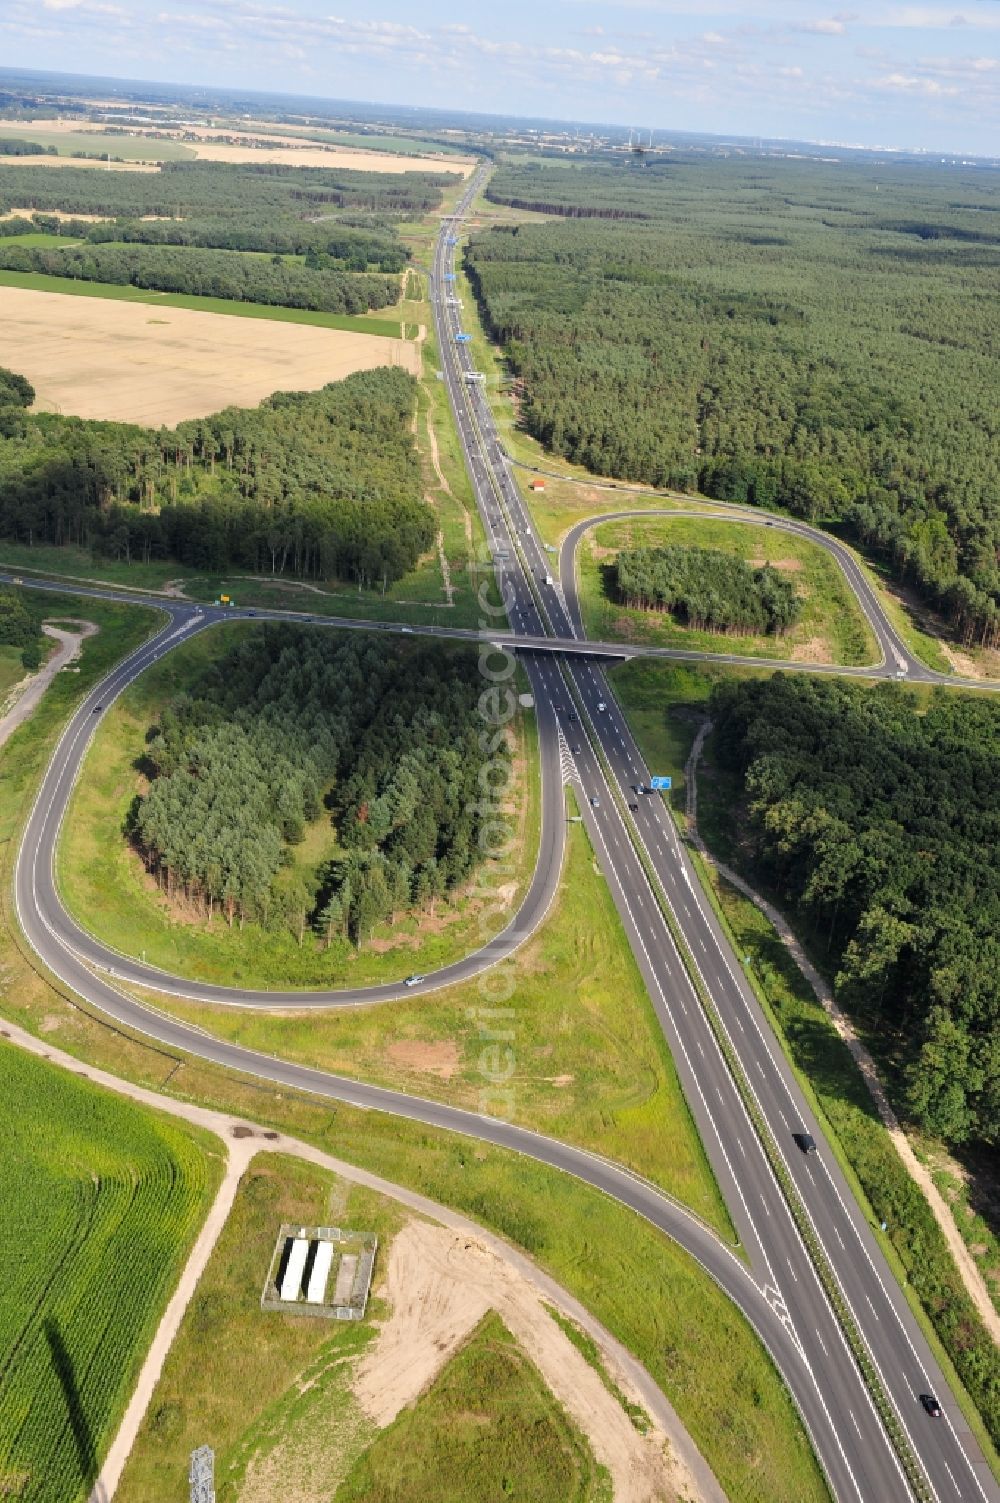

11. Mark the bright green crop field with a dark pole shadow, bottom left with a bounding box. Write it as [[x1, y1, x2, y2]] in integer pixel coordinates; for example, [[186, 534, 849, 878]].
[[0, 1045, 221, 1503]]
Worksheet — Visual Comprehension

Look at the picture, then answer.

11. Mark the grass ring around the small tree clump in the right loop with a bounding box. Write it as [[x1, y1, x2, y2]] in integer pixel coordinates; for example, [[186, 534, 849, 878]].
[[577, 517, 878, 664]]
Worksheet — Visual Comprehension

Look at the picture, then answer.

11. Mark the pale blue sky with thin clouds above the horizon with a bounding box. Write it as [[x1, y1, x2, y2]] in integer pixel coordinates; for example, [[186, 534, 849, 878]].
[[0, 0, 1000, 155]]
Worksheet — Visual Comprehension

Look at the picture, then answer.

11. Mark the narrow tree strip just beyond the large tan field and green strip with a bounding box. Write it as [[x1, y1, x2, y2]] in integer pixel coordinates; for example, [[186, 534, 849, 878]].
[[0, 243, 400, 313]]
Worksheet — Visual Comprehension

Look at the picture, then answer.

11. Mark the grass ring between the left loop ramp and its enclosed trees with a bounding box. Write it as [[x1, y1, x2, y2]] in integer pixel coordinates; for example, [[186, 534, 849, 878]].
[[56, 622, 540, 987]]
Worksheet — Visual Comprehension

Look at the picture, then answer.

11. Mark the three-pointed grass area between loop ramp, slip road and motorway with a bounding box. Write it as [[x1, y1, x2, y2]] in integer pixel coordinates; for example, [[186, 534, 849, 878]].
[[140, 805, 735, 1246]]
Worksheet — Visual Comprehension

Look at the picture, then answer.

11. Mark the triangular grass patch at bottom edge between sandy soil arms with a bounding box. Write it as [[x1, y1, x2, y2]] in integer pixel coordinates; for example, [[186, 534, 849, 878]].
[[334, 1314, 612, 1503]]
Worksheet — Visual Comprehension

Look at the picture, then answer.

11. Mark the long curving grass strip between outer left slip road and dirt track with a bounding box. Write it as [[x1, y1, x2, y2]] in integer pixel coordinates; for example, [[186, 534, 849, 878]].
[[0, 601, 829, 1503]]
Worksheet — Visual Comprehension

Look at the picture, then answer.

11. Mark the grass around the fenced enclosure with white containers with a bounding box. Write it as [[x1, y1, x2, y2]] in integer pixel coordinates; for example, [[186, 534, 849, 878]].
[[116, 1153, 405, 1503]]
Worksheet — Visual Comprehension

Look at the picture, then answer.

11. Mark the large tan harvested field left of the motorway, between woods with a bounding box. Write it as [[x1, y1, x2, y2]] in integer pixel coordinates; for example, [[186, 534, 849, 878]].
[[0, 287, 420, 427]]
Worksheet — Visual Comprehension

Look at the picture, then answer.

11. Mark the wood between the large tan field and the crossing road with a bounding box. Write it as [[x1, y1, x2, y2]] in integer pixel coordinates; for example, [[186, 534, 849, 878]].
[[0, 367, 435, 589]]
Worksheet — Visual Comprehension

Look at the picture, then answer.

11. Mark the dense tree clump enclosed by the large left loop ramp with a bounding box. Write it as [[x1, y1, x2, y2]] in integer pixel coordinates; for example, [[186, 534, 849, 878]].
[[125, 625, 508, 948]]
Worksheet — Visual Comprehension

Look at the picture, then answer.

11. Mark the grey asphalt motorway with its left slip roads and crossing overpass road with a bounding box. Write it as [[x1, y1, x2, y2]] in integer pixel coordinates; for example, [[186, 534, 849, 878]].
[[15, 164, 1000, 1503]]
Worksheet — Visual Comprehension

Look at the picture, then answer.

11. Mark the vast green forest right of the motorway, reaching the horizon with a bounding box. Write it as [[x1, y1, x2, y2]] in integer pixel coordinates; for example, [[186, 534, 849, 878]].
[[466, 158, 1000, 645]]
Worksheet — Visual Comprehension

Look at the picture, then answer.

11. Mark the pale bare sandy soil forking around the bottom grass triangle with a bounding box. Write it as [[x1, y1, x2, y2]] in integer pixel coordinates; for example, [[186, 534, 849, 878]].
[[355, 1220, 701, 1503]]
